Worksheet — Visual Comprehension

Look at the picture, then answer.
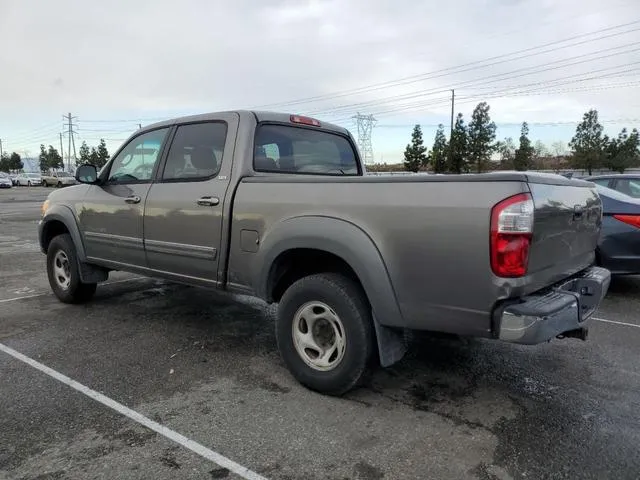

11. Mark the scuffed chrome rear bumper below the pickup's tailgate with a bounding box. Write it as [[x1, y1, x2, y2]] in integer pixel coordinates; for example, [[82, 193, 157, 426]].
[[495, 267, 611, 345]]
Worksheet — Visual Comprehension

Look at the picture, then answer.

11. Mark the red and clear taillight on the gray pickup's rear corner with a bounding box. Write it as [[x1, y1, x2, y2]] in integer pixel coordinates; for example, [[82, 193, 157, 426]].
[[490, 193, 534, 278]]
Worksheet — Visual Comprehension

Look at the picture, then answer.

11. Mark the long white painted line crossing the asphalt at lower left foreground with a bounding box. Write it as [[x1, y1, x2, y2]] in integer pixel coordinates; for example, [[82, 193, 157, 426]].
[[0, 343, 267, 480]]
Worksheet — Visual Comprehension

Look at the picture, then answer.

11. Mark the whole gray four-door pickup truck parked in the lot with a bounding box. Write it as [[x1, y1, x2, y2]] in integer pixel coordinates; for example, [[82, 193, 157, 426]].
[[39, 111, 610, 395]]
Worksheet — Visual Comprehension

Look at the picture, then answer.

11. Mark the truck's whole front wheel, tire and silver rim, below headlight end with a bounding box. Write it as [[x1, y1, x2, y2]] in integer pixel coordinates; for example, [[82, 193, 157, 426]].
[[47, 233, 97, 303]]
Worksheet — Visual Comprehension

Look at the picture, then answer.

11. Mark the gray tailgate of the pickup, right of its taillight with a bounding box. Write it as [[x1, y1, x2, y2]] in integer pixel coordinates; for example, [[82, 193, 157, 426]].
[[528, 177, 602, 281]]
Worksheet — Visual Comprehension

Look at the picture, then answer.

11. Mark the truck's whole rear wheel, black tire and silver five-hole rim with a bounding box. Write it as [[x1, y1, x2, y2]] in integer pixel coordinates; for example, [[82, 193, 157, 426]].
[[276, 273, 374, 395]]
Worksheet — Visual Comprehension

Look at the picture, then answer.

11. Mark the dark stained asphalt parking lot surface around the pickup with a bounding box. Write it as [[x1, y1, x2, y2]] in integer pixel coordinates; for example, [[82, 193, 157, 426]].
[[0, 187, 640, 480]]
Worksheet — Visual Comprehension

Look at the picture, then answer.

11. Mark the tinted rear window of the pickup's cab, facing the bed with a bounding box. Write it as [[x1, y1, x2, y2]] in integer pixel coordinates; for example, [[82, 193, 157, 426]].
[[253, 123, 361, 175]]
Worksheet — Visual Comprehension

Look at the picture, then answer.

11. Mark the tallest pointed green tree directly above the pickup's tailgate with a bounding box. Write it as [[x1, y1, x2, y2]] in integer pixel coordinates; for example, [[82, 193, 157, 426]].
[[569, 109, 608, 175]]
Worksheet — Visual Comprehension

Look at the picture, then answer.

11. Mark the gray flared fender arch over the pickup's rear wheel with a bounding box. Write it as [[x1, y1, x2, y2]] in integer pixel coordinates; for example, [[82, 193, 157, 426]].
[[253, 215, 404, 327]]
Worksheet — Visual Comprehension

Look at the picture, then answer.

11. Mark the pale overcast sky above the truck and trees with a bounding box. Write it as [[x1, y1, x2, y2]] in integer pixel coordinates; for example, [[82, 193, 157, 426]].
[[0, 0, 640, 163]]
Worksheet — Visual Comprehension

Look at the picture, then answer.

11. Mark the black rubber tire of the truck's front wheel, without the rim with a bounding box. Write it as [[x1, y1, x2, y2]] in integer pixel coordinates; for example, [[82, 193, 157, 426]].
[[47, 233, 97, 303]]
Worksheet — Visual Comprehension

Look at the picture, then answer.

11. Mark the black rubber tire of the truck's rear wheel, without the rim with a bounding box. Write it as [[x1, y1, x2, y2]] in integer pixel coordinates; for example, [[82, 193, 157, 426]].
[[276, 273, 375, 396]]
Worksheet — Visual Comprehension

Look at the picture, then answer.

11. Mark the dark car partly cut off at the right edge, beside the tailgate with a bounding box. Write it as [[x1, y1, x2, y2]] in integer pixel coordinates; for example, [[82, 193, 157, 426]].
[[589, 184, 640, 275]]
